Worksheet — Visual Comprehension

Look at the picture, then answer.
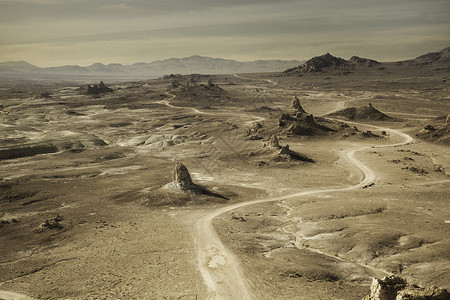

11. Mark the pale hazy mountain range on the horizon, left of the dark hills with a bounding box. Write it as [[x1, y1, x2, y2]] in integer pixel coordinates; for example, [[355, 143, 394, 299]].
[[0, 55, 303, 77]]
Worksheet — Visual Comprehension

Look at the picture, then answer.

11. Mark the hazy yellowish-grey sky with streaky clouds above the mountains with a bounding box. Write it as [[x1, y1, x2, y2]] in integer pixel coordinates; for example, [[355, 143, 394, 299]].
[[0, 0, 450, 66]]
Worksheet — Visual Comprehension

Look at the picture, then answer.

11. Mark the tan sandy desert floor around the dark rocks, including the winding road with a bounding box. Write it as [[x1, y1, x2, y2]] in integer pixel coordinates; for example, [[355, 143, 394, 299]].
[[0, 67, 450, 299]]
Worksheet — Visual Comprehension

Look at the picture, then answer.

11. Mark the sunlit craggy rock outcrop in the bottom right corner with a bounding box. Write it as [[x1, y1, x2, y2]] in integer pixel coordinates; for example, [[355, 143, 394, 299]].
[[363, 275, 450, 300]]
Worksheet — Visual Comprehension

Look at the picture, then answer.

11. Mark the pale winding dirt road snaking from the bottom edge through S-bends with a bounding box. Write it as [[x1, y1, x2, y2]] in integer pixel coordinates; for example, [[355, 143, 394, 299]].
[[193, 123, 413, 299]]
